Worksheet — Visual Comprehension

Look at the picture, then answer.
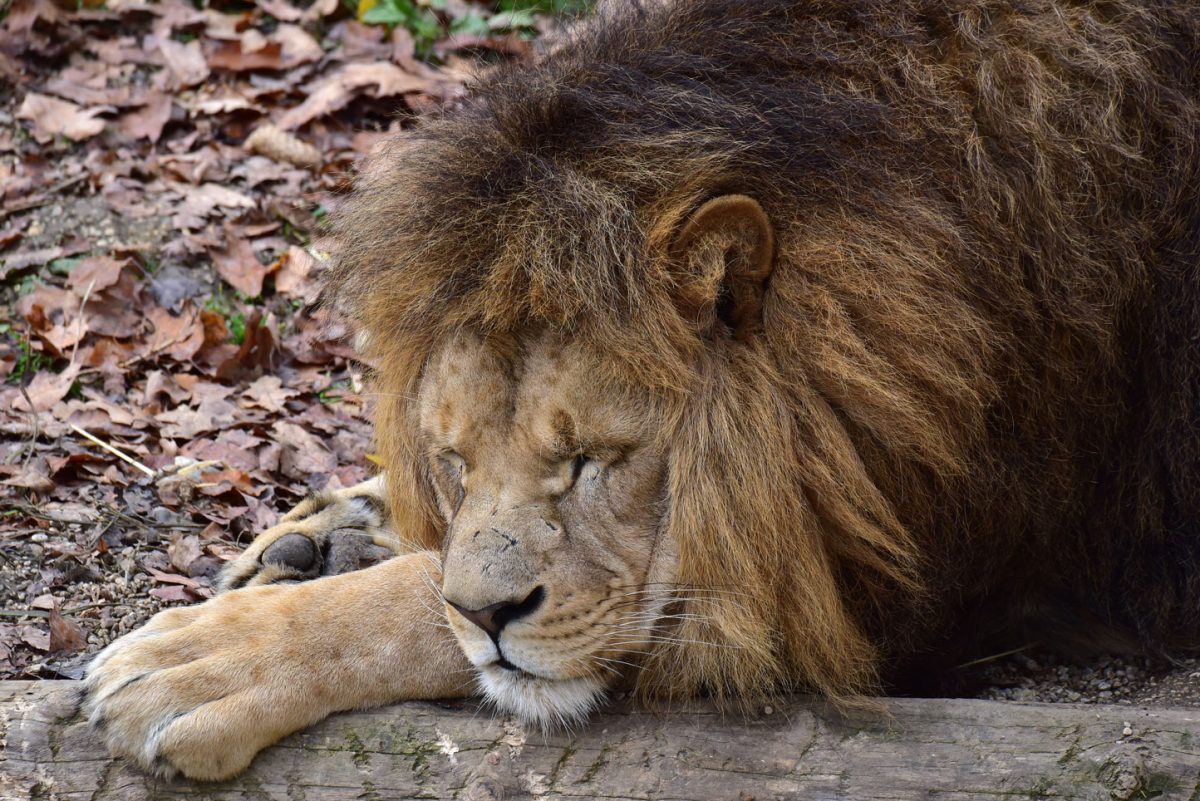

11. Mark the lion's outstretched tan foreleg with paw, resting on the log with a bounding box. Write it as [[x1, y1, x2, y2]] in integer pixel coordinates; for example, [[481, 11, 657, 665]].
[[83, 552, 473, 779]]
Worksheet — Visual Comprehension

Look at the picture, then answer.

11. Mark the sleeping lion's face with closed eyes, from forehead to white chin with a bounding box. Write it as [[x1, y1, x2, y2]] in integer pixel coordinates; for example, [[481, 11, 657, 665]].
[[419, 333, 676, 724]]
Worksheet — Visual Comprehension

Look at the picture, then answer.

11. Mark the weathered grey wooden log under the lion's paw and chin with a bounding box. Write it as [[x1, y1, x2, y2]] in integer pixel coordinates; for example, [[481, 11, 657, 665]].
[[0, 681, 1200, 801]]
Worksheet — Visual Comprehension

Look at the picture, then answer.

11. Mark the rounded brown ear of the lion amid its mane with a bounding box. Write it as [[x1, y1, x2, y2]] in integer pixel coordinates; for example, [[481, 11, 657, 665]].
[[672, 194, 775, 341]]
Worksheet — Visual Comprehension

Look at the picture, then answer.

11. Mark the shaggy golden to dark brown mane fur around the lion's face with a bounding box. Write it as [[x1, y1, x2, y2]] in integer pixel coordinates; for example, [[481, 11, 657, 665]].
[[329, 0, 1200, 695]]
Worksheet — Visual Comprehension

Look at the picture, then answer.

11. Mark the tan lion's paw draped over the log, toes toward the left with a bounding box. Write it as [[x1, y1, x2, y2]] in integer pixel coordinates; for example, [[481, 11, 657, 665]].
[[82, 588, 328, 779]]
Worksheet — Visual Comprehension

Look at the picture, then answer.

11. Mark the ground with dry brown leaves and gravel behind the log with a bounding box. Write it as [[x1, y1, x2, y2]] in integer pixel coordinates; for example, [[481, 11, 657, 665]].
[[0, 0, 1200, 705]]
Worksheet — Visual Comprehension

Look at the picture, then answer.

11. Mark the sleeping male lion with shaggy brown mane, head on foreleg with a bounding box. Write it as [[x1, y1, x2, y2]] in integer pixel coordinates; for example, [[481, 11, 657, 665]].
[[79, 0, 1200, 778]]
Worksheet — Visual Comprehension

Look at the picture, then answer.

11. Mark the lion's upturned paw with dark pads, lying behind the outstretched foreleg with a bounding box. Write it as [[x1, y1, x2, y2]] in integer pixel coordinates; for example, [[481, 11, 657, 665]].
[[218, 475, 412, 591]]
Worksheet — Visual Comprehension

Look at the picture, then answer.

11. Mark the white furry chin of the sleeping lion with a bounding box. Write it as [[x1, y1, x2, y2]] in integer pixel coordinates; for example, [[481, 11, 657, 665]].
[[479, 664, 605, 731]]
